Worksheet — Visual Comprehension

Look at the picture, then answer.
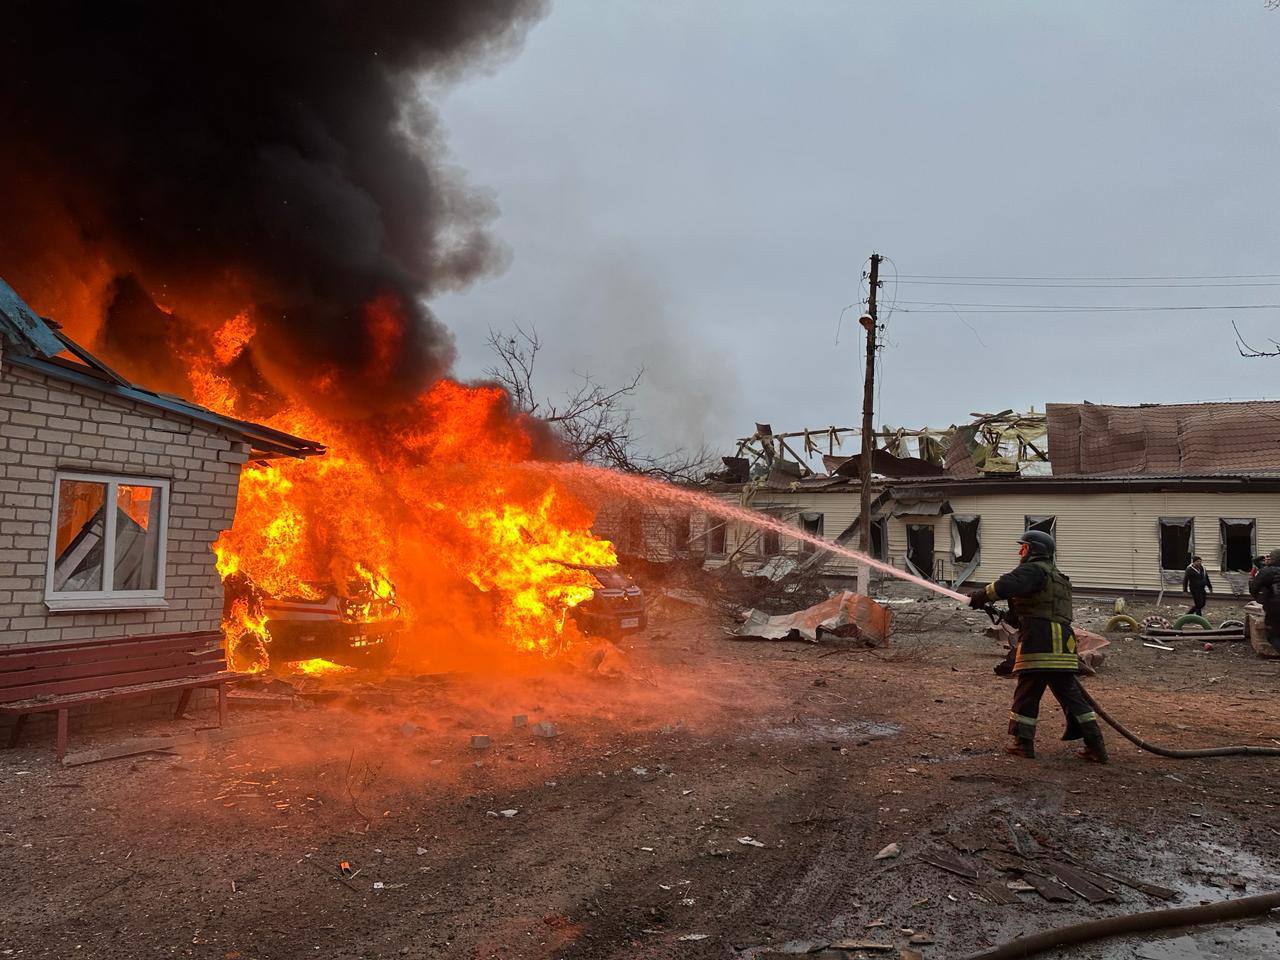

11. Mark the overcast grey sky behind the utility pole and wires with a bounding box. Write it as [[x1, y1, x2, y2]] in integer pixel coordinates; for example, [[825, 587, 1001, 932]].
[[434, 0, 1280, 463]]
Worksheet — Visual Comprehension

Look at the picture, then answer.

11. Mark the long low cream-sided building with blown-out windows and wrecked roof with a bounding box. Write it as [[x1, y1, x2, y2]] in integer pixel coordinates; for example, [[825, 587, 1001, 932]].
[[691, 402, 1280, 594]]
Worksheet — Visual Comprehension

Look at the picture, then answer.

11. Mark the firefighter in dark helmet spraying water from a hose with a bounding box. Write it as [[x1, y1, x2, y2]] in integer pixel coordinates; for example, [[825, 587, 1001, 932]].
[[969, 530, 1107, 763]]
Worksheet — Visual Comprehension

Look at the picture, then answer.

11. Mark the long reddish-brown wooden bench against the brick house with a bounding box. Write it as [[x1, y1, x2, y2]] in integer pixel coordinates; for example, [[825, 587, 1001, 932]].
[[0, 630, 248, 760]]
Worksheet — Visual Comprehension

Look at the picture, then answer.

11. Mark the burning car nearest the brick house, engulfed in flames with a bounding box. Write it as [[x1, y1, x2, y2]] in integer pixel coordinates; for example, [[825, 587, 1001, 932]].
[[223, 577, 403, 667]]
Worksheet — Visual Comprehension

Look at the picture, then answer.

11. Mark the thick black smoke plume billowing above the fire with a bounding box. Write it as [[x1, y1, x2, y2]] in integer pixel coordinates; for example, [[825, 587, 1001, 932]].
[[0, 0, 544, 407]]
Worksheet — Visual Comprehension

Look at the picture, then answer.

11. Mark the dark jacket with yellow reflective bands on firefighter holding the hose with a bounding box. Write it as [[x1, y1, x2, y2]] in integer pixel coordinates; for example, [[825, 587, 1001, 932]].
[[987, 557, 1080, 673]]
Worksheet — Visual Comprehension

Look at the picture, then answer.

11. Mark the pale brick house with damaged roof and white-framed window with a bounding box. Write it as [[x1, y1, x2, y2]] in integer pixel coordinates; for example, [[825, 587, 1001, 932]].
[[0, 280, 324, 644]]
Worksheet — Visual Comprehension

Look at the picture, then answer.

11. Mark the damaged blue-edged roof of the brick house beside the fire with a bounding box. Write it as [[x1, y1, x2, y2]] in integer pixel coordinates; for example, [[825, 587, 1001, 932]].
[[0, 279, 325, 458]]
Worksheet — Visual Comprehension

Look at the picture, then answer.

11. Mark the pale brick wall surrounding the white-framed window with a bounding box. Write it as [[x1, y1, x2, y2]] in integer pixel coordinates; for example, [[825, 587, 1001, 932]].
[[0, 364, 248, 644]]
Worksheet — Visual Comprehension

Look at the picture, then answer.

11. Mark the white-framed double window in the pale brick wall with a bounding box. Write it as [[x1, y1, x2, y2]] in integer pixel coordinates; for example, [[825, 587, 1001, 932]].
[[45, 472, 169, 608]]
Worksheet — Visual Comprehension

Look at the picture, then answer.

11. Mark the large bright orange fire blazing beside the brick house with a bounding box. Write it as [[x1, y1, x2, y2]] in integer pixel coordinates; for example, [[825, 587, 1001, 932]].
[[188, 301, 617, 668]]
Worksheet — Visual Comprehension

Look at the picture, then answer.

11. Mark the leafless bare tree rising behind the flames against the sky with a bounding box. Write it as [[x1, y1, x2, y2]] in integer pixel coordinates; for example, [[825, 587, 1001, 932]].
[[485, 324, 712, 483]]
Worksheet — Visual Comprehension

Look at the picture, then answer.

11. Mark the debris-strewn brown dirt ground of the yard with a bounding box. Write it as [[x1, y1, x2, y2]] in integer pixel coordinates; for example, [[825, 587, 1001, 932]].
[[0, 586, 1280, 960]]
